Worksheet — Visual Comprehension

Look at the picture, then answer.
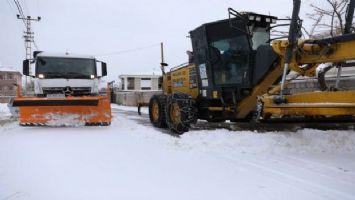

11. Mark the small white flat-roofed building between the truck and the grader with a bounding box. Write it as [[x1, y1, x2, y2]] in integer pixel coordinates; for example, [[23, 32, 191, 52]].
[[119, 75, 161, 91]]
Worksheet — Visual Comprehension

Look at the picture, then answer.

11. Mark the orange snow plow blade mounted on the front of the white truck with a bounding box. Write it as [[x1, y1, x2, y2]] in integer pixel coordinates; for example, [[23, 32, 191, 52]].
[[13, 96, 111, 126]]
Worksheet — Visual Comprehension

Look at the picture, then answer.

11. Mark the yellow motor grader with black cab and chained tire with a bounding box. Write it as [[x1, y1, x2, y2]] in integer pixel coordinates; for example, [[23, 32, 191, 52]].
[[149, 0, 355, 134]]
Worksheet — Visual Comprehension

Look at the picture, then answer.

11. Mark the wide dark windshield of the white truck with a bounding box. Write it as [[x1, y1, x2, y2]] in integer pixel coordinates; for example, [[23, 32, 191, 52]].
[[36, 57, 96, 79]]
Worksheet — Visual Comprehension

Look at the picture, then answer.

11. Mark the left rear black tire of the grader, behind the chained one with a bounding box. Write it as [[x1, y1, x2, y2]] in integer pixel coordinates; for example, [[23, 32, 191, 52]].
[[149, 95, 167, 128]]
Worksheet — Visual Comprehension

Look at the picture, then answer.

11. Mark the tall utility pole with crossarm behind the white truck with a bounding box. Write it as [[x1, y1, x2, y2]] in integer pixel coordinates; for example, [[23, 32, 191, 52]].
[[17, 15, 41, 93]]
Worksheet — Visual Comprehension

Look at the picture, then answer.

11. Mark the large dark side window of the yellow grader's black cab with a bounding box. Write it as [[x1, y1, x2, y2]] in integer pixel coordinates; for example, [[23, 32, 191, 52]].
[[207, 20, 251, 85]]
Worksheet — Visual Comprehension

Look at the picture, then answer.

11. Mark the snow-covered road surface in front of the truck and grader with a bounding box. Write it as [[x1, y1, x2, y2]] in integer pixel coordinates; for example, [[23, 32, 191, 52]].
[[0, 106, 355, 200]]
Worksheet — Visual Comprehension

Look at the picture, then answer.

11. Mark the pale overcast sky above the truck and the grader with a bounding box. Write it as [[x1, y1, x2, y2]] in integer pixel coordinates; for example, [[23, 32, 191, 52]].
[[0, 0, 310, 80]]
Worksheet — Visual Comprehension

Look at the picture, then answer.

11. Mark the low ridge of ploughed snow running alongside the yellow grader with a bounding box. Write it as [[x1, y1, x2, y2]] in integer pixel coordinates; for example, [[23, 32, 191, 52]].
[[179, 129, 355, 153]]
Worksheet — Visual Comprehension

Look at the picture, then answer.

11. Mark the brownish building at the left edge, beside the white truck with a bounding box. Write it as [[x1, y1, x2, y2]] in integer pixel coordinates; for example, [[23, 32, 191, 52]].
[[0, 68, 22, 103]]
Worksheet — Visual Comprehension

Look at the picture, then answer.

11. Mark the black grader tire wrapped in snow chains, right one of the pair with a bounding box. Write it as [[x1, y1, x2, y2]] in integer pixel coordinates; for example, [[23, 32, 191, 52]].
[[165, 93, 197, 134]]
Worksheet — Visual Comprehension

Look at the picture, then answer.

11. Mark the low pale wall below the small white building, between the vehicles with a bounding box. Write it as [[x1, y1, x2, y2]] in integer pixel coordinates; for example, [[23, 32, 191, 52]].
[[113, 91, 162, 106]]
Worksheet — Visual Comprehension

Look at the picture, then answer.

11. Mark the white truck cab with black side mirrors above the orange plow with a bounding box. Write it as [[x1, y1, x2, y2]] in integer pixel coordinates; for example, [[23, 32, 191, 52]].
[[23, 52, 107, 97]]
